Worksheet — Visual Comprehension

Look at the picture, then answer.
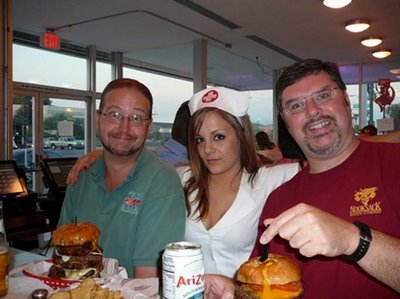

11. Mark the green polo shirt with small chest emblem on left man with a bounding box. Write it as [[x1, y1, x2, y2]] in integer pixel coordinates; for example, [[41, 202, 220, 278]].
[[59, 149, 186, 277]]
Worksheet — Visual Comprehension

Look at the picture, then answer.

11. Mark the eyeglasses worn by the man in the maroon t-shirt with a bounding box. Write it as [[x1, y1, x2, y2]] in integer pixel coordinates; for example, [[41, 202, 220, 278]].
[[282, 87, 338, 114]]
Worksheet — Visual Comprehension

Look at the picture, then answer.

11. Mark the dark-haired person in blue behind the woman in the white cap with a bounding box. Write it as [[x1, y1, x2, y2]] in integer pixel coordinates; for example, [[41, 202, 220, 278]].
[[154, 101, 190, 167]]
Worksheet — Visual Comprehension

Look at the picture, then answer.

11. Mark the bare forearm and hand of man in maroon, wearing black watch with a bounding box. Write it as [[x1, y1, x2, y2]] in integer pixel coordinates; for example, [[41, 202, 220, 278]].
[[260, 203, 400, 292]]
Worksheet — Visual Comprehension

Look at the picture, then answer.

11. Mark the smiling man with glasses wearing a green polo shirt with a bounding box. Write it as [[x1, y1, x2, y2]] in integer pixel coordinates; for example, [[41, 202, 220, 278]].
[[59, 79, 185, 278]]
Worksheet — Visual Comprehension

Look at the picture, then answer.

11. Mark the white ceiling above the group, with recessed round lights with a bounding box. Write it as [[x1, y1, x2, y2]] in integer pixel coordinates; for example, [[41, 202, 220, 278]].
[[13, 0, 400, 90]]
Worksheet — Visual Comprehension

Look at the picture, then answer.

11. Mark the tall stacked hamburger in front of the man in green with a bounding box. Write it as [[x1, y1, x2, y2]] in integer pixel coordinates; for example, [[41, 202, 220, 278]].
[[48, 222, 103, 280]]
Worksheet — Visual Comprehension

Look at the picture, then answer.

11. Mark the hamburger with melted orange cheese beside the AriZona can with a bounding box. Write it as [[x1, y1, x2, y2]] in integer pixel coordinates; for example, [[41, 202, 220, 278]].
[[235, 253, 303, 299]]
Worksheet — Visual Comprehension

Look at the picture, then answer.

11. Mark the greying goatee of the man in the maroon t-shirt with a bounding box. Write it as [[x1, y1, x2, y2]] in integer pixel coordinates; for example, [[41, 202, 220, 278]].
[[304, 116, 343, 156]]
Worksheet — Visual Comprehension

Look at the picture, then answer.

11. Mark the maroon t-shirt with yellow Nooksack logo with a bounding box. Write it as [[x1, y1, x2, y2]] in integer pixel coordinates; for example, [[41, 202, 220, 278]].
[[252, 141, 400, 299]]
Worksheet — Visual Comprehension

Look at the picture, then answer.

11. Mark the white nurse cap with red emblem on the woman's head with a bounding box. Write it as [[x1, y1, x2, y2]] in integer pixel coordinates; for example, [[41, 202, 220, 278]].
[[189, 87, 250, 117]]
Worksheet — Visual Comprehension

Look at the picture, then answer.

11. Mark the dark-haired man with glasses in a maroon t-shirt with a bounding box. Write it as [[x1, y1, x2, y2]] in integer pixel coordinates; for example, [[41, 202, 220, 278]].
[[252, 59, 400, 299]]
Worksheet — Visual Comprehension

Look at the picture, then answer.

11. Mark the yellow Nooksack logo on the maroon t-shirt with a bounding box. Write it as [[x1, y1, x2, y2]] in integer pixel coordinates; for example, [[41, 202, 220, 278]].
[[350, 187, 382, 216]]
